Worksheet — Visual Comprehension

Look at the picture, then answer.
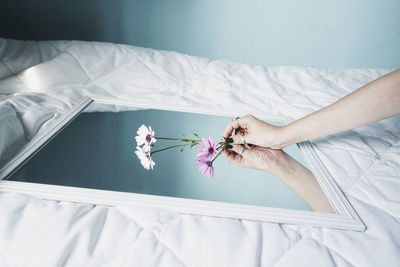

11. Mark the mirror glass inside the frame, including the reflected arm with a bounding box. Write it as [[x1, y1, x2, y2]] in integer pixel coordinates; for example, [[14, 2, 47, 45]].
[[7, 101, 334, 213]]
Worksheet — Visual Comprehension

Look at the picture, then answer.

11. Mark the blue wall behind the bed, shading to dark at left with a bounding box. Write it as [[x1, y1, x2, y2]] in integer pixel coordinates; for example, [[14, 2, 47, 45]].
[[0, 0, 400, 68]]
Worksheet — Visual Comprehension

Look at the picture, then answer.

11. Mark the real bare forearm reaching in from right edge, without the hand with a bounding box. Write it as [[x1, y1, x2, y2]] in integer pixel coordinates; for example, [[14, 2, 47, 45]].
[[280, 70, 400, 147]]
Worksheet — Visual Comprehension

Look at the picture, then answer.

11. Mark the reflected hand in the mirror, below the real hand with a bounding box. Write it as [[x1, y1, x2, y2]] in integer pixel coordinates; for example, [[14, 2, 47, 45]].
[[223, 145, 290, 176]]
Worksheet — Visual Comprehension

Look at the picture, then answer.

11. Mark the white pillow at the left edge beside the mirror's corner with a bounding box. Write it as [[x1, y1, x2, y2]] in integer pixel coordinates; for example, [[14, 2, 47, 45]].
[[0, 101, 26, 164]]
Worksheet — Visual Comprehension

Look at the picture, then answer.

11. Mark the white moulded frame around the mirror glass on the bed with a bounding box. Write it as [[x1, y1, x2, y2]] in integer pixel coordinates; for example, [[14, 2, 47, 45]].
[[0, 97, 365, 231]]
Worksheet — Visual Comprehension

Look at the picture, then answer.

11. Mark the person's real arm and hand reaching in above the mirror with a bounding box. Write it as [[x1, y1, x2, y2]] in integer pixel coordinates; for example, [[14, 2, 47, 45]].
[[222, 70, 400, 149]]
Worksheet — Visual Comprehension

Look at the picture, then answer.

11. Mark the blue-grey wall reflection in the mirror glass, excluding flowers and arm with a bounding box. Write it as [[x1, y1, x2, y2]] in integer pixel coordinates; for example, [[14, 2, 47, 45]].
[[9, 104, 311, 210]]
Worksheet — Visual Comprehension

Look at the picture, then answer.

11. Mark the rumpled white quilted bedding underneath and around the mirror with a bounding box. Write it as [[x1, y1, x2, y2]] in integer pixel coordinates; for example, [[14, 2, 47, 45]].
[[0, 39, 400, 267]]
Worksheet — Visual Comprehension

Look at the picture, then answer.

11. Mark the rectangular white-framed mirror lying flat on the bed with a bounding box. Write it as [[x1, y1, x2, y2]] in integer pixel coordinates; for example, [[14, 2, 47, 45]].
[[0, 98, 364, 230]]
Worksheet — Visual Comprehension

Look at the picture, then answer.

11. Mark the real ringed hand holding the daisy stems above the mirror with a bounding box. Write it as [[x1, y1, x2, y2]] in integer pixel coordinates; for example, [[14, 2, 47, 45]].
[[222, 115, 284, 149]]
